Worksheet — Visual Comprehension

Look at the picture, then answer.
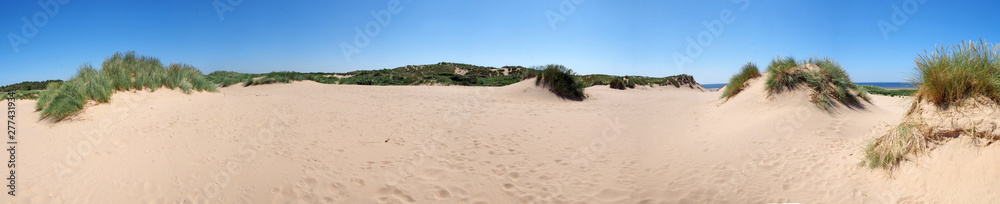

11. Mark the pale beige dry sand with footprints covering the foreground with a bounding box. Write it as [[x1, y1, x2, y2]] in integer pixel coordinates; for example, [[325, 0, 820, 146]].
[[4, 79, 1000, 203]]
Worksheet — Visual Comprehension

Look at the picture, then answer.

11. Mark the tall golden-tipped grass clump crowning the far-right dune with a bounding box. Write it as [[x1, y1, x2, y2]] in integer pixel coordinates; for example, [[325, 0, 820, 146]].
[[915, 40, 1000, 106]]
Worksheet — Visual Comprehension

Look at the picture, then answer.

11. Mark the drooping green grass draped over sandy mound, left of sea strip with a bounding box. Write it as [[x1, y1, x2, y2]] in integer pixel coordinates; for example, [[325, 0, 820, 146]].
[[765, 57, 868, 111]]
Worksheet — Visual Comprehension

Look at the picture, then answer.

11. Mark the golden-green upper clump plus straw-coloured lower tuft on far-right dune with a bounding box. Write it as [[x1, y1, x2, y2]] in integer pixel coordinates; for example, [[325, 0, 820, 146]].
[[862, 40, 1000, 169]]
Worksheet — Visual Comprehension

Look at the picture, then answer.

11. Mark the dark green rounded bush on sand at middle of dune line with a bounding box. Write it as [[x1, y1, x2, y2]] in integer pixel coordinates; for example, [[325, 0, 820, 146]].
[[535, 64, 586, 100]]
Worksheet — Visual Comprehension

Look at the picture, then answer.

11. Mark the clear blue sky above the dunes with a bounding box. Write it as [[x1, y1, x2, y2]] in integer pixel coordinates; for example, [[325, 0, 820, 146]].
[[0, 0, 1000, 84]]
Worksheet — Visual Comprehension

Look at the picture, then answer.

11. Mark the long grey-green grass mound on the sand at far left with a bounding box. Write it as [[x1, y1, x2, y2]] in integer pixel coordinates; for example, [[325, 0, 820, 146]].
[[35, 52, 216, 121]]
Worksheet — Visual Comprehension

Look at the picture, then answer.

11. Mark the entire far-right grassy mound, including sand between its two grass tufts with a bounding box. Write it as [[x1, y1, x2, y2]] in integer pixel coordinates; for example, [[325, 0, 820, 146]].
[[862, 41, 1000, 169]]
